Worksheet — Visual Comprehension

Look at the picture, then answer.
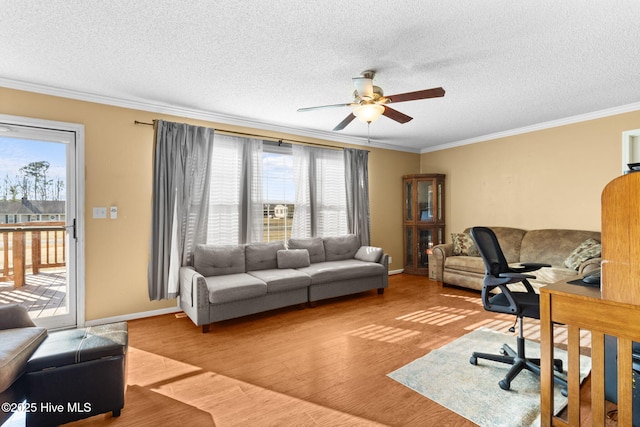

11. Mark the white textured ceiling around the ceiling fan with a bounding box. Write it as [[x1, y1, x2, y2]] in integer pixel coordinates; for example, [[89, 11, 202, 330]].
[[0, 0, 640, 152]]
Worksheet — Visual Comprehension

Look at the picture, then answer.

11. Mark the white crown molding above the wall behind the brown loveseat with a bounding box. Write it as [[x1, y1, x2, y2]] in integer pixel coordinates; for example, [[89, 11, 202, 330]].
[[420, 102, 640, 154]]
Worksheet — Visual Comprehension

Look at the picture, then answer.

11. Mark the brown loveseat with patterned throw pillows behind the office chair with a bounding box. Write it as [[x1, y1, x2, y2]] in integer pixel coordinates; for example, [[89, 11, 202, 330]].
[[432, 227, 601, 290]]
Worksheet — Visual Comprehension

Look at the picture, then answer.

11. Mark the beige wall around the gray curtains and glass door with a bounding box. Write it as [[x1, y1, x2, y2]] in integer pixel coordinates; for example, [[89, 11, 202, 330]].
[[0, 88, 420, 321]]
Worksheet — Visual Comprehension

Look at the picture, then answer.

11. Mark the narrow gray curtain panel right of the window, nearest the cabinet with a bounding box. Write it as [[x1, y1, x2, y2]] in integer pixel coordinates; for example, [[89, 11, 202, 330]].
[[344, 148, 370, 246]]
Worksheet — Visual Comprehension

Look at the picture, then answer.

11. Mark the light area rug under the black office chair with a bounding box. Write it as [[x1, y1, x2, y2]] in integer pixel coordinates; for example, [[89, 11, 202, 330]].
[[388, 329, 591, 427]]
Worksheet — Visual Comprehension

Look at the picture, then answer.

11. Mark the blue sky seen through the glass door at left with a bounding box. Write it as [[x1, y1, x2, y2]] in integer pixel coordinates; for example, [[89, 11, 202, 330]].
[[0, 136, 66, 197]]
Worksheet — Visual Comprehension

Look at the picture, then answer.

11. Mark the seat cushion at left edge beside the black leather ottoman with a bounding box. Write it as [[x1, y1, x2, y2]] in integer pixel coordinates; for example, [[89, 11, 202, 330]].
[[0, 326, 47, 393]]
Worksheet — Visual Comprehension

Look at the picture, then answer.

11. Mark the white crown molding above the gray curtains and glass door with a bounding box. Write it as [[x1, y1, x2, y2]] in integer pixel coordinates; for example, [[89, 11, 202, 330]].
[[0, 77, 420, 153]]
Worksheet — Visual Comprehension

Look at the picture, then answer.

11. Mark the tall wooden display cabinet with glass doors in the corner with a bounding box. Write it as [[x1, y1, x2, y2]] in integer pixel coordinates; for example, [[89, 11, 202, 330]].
[[402, 174, 445, 275]]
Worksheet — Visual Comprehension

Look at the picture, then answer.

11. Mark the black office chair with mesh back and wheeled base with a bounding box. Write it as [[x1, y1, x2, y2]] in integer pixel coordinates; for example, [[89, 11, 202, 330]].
[[469, 227, 567, 394]]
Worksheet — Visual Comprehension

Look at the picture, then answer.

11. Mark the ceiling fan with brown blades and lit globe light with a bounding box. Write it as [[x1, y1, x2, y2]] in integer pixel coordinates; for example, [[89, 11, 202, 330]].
[[298, 70, 444, 131]]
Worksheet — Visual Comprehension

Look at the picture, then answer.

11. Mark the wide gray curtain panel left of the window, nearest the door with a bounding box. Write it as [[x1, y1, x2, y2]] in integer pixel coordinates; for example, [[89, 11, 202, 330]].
[[148, 120, 214, 300]]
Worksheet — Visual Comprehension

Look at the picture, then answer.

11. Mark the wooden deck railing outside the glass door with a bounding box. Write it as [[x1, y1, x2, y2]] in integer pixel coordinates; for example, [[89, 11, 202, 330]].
[[0, 222, 66, 287]]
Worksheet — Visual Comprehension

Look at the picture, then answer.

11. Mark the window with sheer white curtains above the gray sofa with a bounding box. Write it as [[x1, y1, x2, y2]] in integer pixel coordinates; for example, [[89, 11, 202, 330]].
[[207, 134, 347, 245]]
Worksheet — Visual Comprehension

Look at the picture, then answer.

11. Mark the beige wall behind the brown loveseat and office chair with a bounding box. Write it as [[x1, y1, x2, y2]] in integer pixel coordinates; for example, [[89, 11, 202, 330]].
[[420, 111, 640, 237]]
